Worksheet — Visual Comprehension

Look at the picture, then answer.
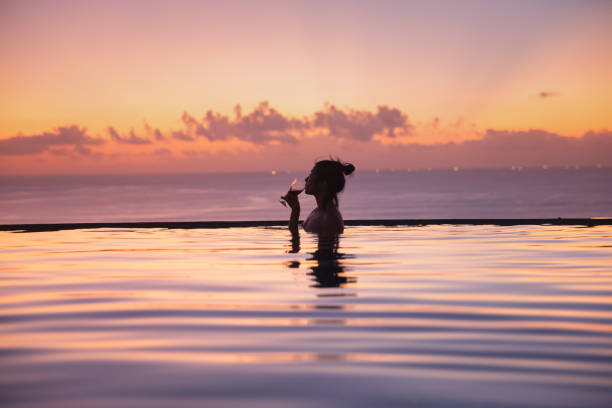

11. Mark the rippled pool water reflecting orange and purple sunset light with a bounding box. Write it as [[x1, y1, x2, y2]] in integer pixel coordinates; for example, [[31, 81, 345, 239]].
[[0, 225, 612, 408]]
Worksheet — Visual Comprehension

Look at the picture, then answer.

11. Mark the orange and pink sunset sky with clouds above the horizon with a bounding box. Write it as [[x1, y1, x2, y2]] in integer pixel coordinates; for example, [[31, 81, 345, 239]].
[[0, 0, 612, 174]]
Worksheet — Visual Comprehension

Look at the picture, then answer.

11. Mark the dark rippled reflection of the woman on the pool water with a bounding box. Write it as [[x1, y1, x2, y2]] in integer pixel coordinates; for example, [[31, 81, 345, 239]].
[[286, 231, 357, 288]]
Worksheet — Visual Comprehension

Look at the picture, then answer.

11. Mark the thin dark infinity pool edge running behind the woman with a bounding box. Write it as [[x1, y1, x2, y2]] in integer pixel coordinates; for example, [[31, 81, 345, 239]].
[[0, 218, 612, 232]]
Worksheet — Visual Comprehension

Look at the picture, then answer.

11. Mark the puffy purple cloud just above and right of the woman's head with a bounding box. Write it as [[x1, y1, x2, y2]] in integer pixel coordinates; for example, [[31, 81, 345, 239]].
[[313, 105, 413, 141]]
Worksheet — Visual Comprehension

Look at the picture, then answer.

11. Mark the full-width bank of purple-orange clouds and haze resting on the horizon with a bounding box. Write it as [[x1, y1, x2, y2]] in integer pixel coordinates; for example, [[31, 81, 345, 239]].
[[0, 102, 612, 173]]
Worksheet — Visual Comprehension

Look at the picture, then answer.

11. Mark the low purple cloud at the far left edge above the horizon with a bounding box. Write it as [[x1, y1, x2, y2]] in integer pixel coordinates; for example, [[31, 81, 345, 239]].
[[0, 125, 104, 155]]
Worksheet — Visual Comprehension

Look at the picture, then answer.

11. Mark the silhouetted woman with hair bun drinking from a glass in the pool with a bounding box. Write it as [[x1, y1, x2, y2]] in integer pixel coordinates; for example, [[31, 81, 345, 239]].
[[281, 160, 355, 236]]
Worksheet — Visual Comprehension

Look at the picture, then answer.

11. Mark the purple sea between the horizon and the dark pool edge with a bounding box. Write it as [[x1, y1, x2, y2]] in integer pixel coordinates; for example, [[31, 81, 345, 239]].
[[0, 168, 612, 224]]
